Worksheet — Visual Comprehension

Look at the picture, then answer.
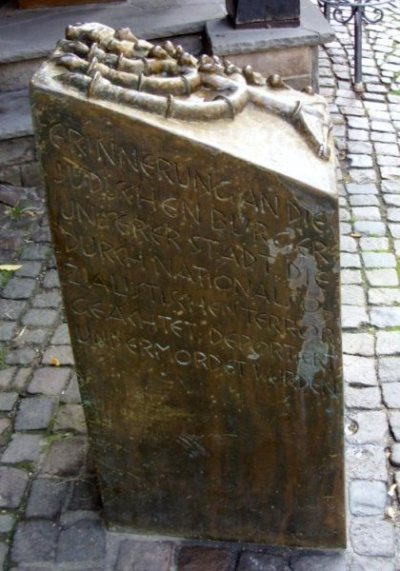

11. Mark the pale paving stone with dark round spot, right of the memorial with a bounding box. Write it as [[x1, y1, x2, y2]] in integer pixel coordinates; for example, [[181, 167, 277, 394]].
[[345, 410, 388, 444]]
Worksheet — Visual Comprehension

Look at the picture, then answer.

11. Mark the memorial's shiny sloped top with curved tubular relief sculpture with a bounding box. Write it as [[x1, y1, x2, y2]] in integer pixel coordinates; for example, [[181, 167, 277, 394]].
[[33, 23, 335, 194]]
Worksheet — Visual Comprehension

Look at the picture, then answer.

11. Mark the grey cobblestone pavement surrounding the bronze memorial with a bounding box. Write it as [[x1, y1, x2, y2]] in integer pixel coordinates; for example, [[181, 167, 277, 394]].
[[0, 2, 400, 571]]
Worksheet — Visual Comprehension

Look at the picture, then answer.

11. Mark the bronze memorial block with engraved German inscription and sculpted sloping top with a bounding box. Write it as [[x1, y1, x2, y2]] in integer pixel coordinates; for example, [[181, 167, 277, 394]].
[[31, 24, 345, 548]]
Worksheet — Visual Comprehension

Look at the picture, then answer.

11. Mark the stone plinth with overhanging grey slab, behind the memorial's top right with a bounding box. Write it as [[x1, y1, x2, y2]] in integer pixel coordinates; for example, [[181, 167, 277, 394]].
[[206, 0, 334, 91]]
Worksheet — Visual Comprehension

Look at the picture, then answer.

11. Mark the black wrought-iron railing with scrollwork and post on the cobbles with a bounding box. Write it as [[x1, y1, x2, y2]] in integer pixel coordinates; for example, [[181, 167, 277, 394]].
[[318, 0, 392, 91]]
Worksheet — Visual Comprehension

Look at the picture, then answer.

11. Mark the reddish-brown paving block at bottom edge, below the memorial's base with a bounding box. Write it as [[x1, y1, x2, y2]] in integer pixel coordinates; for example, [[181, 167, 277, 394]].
[[176, 546, 236, 571]]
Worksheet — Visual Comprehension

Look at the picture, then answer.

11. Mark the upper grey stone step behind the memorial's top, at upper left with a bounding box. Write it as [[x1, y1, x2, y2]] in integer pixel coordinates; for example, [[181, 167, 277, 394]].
[[0, 0, 225, 92]]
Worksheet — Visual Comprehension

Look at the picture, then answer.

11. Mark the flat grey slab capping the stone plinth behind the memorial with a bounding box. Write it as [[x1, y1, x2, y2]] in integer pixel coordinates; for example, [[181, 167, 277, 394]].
[[206, 0, 334, 55]]
